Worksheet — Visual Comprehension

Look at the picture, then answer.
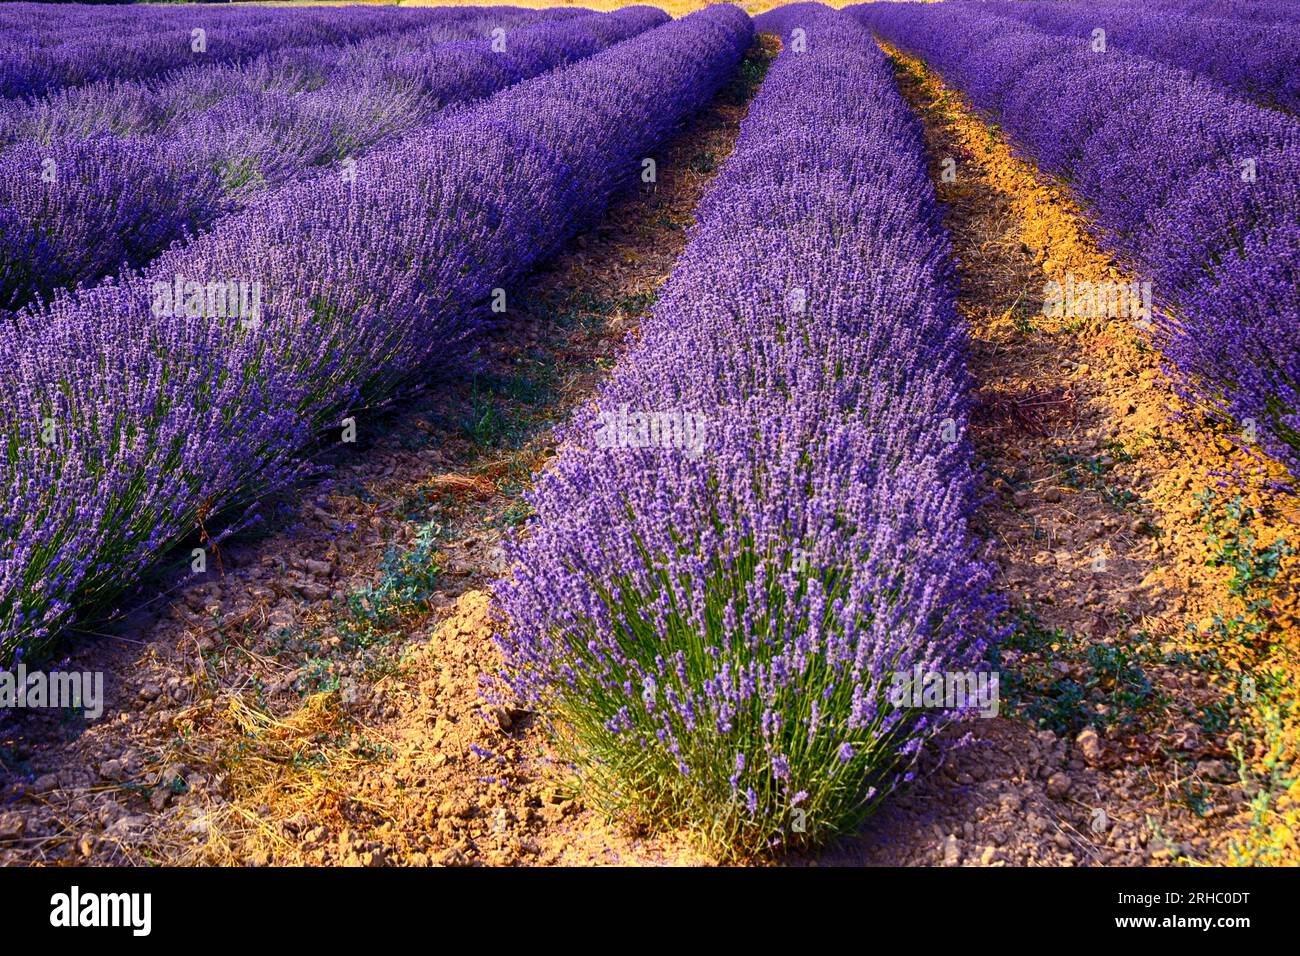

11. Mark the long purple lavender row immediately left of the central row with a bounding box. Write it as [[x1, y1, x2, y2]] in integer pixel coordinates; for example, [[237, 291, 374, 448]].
[[0, 7, 753, 659]]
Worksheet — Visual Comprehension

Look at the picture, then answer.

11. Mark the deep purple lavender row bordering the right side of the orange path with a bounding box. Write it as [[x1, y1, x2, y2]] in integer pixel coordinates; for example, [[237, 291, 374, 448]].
[[852, 3, 1300, 486]]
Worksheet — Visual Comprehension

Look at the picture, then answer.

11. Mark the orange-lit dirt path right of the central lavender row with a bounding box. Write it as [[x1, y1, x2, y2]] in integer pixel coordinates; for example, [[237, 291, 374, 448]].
[[822, 51, 1300, 865]]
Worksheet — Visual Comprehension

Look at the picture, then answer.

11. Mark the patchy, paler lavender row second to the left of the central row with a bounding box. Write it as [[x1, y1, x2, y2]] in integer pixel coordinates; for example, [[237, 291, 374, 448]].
[[0, 7, 668, 320]]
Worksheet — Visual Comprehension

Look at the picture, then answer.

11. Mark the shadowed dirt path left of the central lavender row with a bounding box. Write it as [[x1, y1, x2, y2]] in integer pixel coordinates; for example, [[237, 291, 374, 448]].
[[0, 47, 775, 866]]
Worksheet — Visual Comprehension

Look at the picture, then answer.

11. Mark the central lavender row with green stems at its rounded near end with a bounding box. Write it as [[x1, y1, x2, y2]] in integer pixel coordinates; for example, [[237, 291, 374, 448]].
[[497, 4, 1000, 855]]
